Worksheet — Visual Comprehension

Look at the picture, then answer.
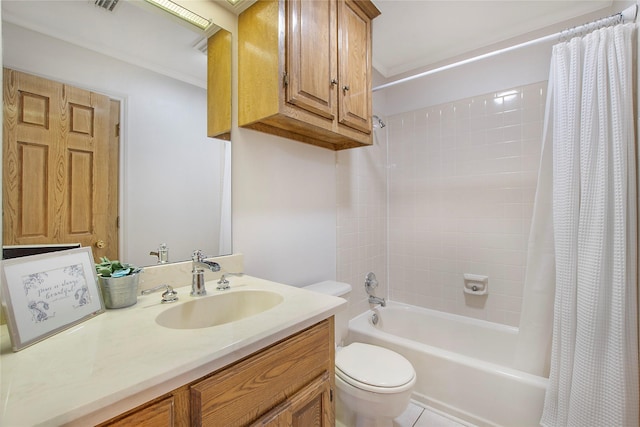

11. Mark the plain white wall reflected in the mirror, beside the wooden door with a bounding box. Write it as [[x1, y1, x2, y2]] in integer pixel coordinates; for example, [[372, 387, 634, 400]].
[[2, 23, 224, 268]]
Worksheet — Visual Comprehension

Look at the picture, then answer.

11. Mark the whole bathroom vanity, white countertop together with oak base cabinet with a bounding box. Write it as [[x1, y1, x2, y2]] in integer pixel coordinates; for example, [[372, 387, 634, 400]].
[[0, 275, 345, 426]]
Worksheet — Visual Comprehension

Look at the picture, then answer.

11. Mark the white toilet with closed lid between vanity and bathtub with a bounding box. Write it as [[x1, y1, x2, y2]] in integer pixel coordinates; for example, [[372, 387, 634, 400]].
[[305, 280, 416, 427]]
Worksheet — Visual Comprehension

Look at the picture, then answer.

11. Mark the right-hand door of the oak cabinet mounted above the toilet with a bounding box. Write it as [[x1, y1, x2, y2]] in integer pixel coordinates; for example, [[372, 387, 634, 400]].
[[338, 0, 371, 133]]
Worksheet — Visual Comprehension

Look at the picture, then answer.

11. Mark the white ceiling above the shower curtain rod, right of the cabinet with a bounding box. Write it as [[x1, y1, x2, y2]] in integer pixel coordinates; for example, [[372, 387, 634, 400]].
[[373, 0, 612, 77]]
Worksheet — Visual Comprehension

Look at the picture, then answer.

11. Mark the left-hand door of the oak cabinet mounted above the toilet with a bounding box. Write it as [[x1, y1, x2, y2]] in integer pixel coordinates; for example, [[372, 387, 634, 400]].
[[283, 0, 338, 120]]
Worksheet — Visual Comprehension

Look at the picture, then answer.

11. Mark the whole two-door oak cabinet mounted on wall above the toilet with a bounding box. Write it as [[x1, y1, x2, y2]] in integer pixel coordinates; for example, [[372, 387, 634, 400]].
[[238, 0, 380, 150]]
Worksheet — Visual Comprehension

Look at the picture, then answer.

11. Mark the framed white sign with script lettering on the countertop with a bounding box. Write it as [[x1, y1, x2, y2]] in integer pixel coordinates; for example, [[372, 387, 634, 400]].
[[2, 247, 104, 351]]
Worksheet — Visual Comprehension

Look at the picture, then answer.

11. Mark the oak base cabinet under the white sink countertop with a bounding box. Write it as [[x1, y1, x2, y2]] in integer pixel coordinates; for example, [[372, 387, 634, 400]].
[[103, 317, 335, 427]]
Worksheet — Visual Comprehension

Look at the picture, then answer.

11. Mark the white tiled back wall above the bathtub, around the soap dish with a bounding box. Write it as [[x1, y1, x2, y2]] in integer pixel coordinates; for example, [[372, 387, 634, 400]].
[[388, 82, 546, 326]]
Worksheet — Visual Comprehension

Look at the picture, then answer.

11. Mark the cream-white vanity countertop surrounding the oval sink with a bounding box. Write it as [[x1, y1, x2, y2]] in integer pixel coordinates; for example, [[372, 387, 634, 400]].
[[0, 275, 345, 427]]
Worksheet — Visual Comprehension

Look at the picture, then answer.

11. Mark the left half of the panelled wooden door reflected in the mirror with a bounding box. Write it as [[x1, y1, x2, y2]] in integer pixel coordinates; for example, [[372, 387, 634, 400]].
[[2, 70, 63, 244]]
